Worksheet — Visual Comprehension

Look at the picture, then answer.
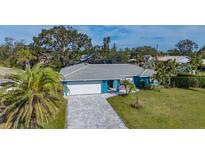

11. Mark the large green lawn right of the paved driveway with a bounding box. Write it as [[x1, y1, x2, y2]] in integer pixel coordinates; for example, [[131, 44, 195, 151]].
[[108, 88, 205, 128]]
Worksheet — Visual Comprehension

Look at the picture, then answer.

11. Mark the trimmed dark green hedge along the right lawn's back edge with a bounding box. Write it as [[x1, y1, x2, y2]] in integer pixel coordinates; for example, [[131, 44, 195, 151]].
[[171, 76, 205, 88]]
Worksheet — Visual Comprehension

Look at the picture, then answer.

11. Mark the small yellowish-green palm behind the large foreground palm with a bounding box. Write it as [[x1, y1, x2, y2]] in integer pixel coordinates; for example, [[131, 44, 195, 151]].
[[17, 49, 35, 69]]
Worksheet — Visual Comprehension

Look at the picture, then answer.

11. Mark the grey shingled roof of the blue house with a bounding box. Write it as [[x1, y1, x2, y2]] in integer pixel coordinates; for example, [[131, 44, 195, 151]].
[[60, 63, 154, 81]]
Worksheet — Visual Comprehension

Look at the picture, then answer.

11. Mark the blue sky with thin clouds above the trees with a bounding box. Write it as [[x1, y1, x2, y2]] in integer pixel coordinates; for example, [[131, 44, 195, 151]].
[[0, 25, 205, 51]]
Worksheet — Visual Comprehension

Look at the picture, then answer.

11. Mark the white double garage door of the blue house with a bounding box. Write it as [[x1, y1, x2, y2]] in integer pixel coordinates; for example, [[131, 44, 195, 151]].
[[67, 81, 101, 95]]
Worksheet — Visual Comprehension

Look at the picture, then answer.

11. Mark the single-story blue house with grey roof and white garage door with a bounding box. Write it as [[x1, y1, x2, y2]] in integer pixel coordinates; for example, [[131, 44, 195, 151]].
[[60, 63, 154, 96]]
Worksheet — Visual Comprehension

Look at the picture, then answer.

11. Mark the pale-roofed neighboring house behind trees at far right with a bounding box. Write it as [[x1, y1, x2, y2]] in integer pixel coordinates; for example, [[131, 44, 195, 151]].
[[157, 56, 190, 64]]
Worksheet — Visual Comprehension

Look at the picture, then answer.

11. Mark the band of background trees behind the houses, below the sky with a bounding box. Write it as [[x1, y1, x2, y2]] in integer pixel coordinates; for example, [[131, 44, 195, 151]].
[[0, 26, 204, 71]]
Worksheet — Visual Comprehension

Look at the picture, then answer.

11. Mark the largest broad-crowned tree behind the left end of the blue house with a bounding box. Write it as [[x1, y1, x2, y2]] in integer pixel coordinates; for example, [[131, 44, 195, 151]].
[[31, 26, 92, 67]]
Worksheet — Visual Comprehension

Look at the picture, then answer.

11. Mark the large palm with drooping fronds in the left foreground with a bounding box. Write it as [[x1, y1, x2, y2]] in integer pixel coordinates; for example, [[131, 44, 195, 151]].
[[0, 64, 64, 128]]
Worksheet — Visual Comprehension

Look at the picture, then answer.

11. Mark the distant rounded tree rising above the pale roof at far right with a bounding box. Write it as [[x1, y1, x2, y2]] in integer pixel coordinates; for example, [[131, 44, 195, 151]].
[[176, 39, 198, 55]]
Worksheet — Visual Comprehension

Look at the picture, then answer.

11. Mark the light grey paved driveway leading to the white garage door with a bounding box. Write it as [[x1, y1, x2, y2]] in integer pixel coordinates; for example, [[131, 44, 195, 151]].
[[67, 95, 126, 129]]
